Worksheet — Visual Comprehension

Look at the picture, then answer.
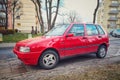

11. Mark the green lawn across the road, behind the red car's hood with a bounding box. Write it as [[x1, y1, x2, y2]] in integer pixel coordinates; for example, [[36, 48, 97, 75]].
[[3, 33, 42, 42]]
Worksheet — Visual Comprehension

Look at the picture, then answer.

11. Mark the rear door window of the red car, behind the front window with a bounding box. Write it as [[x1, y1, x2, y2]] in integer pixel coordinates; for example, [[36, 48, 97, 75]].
[[86, 24, 98, 36]]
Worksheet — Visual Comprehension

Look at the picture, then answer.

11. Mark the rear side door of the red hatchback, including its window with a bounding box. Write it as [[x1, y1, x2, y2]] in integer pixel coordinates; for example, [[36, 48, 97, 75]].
[[86, 24, 101, 53]]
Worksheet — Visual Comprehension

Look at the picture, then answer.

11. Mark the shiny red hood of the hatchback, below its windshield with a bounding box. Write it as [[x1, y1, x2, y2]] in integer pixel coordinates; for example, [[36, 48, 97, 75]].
[[17, 36, 60, 46]]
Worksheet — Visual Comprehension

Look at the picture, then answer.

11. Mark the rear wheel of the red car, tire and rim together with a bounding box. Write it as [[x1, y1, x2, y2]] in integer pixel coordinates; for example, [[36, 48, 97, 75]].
[[96, 45, 107, 58]]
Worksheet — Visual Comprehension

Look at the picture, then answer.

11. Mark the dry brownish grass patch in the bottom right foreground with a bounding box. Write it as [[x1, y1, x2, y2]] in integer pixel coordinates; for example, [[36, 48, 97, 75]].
[[42, 64, 120, 80]]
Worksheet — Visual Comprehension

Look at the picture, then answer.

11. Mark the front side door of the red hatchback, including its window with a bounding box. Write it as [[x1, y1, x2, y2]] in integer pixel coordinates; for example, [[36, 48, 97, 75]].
[[65, 24, 86, 56]]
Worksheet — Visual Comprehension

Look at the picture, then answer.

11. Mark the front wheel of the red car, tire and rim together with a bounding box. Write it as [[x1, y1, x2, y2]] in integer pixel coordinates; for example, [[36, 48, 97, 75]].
[[39, 50, 59, 69]]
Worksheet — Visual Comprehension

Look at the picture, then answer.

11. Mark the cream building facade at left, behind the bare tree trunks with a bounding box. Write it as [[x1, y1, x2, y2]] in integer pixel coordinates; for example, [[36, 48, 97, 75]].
[[15, 0, 40, 33]]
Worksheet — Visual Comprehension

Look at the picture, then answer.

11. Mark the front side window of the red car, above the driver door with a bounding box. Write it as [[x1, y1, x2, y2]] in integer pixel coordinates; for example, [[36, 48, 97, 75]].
[[69, 24, 84, 36]]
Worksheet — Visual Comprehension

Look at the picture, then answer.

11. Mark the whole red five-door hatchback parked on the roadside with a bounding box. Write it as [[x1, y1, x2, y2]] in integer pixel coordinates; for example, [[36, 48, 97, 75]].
[[13, 23, 109, 69]]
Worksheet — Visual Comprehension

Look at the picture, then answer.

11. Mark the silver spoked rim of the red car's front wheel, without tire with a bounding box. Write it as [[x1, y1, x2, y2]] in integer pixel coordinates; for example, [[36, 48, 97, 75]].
[[43, 54, 56, 67]]
